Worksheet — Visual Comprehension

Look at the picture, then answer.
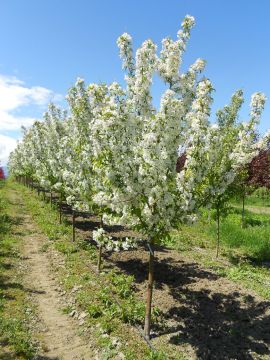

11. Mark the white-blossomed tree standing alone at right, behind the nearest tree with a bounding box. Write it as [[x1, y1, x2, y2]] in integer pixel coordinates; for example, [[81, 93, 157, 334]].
[[195, 90, 265, 256]]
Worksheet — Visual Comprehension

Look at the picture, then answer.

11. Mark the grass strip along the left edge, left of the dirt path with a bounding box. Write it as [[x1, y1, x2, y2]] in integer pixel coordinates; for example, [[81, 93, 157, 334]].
[[0, 182, 36, 359]]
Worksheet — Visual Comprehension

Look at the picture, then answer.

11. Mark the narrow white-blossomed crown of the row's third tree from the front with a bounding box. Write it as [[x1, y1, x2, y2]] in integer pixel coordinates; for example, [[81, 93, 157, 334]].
[[63, 79, 96, 212]]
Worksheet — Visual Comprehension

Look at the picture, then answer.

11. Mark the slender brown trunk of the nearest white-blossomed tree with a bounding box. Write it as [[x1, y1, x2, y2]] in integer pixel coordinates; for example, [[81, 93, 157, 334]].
[[144, 243, 155, 340]]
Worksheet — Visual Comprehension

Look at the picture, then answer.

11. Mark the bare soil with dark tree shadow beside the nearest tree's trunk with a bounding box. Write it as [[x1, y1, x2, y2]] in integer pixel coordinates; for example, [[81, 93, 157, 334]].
[[107, 252, 270, 360]]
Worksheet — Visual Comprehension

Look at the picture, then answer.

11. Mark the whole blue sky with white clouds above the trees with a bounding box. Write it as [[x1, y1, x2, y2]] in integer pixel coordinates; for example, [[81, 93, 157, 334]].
[[0, 0, 270, 162]]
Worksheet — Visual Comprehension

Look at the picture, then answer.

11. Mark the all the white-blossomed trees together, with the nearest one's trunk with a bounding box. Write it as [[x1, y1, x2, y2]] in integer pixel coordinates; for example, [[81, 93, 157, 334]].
[[9, 16, 269, 338]]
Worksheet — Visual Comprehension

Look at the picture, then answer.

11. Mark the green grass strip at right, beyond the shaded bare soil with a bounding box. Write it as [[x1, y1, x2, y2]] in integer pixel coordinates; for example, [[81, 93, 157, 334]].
[[172, 202, 270, 300]]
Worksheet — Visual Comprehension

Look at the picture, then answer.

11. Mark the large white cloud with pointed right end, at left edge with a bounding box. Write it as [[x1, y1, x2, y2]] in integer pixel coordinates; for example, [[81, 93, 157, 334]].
[[0, 74, 61, 131]]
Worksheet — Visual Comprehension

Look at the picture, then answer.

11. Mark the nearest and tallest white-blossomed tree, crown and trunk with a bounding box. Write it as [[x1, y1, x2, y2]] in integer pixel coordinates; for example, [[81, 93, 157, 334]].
[[88, 16, 219, 338]]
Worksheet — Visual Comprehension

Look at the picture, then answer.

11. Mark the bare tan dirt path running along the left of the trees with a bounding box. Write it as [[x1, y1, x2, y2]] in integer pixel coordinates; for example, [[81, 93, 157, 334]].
[[10, 192, 95, 360]]
